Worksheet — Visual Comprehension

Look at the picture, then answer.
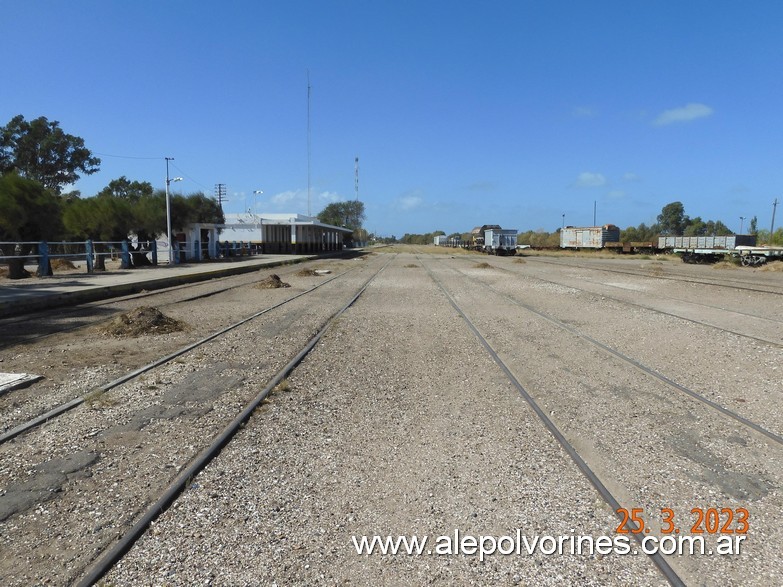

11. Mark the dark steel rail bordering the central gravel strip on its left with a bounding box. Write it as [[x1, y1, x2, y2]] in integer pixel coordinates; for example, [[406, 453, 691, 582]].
[[76, 258, 393, 587]]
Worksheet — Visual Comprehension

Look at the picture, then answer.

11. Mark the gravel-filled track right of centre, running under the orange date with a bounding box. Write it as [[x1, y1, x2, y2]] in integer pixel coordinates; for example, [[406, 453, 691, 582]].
[[414, 260, 783, 584]]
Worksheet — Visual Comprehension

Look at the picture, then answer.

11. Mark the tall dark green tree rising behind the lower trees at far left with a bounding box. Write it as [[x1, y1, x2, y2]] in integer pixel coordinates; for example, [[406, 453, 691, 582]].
[[0, 114, 101, 194]]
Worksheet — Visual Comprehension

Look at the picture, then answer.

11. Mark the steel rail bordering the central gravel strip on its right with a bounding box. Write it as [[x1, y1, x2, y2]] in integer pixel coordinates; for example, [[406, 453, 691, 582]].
[[419, 259, 685, 587]]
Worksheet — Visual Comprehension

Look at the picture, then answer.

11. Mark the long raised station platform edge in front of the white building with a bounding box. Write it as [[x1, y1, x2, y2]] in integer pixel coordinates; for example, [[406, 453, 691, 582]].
[[0, 255, 312, 318]]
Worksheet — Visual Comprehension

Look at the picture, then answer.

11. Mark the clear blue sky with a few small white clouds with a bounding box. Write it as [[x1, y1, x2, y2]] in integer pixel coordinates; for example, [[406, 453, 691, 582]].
[[6, 0, 783, 236]]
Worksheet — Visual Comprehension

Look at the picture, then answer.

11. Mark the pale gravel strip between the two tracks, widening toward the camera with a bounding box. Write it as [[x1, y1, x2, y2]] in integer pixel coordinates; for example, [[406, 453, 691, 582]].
[[107, 258, 663, 585]]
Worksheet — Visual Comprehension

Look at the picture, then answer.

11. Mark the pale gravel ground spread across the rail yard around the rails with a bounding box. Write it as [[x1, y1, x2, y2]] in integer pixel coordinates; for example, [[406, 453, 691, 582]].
[[0, 249, 783, 585]]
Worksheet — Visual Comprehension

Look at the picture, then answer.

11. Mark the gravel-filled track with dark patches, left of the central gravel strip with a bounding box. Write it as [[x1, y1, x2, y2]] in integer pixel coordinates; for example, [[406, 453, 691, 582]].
[[0, 255, 392, 584]]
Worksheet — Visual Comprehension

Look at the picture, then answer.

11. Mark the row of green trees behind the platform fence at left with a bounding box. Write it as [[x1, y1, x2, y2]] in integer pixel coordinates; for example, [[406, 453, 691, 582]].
[[0, 115, 225, 241]]
